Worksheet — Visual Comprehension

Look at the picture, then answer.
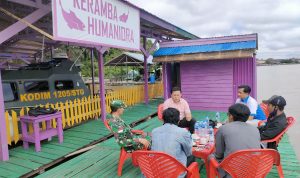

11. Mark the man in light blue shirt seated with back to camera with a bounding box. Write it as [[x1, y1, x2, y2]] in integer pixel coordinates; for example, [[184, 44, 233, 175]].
[[151, 108, 194, 177]]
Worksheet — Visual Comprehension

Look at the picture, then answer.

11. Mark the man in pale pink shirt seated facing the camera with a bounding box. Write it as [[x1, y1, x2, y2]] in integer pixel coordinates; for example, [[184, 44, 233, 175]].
[[164, 87, 196, 133]]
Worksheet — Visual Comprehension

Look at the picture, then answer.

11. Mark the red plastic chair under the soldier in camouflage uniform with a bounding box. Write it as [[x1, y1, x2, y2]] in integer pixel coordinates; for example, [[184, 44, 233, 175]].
[[103, 120, 144, 176]]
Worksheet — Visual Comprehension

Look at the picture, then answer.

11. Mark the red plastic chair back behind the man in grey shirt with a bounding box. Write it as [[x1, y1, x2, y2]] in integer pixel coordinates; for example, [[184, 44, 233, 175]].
[[209, 149, 284, 178]]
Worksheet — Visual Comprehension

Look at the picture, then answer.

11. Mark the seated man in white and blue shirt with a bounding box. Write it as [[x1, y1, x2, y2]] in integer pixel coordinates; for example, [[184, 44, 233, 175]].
[[235, 85, 266, 126]]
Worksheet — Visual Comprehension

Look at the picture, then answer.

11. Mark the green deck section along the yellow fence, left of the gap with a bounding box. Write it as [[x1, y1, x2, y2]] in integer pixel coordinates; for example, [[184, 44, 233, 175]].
[[0, 99, 162, 177]]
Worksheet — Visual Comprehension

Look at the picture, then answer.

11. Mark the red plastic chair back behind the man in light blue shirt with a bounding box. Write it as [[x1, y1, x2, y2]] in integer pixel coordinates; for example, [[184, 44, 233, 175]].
[[132, 151, 200, 178]]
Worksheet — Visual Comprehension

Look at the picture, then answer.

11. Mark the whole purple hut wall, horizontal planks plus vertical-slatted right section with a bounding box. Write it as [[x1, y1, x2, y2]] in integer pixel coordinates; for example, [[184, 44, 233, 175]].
[[180, 58, 256, 111]]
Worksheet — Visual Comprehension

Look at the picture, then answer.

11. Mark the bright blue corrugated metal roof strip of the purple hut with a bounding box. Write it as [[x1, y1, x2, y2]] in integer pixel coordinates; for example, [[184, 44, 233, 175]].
[[153, 40, 256, 57]]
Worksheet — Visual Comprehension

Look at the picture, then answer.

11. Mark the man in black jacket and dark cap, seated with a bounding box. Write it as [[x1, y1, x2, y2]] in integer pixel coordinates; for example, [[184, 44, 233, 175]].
[[259, 96, 287, 150]]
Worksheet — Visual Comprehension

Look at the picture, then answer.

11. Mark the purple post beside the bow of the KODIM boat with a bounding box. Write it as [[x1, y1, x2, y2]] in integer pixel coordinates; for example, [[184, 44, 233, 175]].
[[98, 49, 106, 120]]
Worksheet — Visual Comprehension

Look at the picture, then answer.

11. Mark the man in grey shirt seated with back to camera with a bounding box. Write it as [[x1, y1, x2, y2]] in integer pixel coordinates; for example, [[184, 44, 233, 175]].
[[213, 103, 260, 177]]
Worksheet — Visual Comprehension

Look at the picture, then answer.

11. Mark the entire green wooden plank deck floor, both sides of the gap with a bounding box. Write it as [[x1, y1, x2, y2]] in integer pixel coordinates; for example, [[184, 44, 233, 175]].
[[0, 100, 300, 178]]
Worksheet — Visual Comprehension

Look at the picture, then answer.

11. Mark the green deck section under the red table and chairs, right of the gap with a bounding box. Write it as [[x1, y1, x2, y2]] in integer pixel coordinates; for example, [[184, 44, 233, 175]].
[[38, 111, 300, 178]]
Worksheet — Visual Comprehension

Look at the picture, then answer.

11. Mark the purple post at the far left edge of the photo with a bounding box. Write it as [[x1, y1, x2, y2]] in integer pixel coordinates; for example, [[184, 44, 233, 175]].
[[0, 70, 9, 161]]
